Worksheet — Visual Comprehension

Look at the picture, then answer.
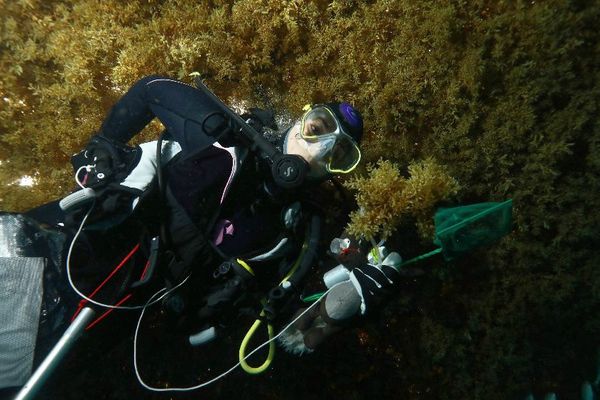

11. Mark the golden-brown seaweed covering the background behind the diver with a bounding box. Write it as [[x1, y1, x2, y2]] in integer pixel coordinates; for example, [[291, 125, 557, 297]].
[[0, 0, 600, 399]]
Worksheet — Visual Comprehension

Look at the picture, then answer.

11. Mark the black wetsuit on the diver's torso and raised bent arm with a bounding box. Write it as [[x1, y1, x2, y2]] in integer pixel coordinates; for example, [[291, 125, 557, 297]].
[[100, 76, 310, 278]]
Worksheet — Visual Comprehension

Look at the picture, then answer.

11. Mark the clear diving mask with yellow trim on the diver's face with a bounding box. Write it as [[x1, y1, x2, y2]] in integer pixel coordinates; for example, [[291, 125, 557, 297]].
[[299, 105, 361, 173]]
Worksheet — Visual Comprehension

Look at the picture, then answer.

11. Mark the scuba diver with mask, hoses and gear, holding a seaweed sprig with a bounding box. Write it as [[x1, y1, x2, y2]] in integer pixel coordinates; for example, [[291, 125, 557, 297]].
[[0, 76, 504, 393]]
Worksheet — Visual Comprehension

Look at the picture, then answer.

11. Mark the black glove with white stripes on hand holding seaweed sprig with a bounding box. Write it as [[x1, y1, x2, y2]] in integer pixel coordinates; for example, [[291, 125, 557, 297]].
[[350, 253, 400, 315]]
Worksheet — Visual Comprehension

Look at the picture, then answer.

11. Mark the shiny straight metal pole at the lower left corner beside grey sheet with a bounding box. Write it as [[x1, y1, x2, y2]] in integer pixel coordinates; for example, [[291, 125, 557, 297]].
[[15, 307, 96, 400]]
